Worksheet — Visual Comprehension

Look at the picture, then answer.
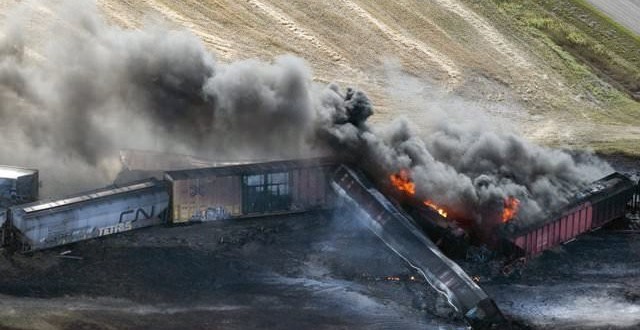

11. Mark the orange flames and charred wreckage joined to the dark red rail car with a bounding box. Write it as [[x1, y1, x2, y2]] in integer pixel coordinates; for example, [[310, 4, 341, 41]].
[[382, 166, 640, 261]]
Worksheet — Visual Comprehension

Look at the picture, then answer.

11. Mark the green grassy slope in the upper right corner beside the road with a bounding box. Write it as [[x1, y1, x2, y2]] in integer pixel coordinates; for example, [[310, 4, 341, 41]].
[[460, 0, 640, 155]]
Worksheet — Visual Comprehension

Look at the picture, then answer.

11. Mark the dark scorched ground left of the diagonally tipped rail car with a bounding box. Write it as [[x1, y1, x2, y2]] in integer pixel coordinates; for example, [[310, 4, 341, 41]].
[[0, 209, 464, 329]]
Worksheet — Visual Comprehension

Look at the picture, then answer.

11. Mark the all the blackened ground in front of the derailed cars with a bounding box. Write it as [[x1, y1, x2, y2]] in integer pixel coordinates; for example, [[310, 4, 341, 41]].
[[0, 202, 640, 329]]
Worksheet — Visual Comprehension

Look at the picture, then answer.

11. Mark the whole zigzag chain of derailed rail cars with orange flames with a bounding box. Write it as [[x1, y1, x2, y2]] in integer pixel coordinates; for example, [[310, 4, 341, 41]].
[[0, 158, 640, 329]]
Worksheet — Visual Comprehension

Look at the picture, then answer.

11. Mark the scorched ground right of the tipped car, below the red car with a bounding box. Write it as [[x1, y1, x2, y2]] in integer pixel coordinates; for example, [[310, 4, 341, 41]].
[[462, 229, 640, 329]]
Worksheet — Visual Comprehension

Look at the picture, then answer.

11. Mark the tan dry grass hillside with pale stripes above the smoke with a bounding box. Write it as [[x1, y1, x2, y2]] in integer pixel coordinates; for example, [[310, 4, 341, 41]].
[[0, 0, 640, 153]]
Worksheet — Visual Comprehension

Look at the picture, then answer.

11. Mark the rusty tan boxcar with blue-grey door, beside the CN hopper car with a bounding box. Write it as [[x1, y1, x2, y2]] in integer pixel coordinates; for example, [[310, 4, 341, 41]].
[[165, 158, 335, 223]]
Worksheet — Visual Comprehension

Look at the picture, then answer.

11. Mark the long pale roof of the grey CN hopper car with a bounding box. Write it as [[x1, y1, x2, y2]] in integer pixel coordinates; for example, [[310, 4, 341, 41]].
[[12, 179, 161, 213]]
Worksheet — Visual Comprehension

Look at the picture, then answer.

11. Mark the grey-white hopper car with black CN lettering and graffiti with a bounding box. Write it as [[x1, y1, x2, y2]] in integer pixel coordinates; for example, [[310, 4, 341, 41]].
[[10, 180, 169, 251]]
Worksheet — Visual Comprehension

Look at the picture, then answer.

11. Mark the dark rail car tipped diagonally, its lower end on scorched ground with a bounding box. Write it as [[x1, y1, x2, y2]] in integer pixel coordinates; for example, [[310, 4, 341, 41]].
[[332, 166, 510, 329]]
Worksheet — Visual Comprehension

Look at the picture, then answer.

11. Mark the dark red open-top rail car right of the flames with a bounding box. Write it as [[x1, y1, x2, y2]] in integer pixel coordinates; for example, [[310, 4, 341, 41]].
[[501, 173, 635, 257]]
